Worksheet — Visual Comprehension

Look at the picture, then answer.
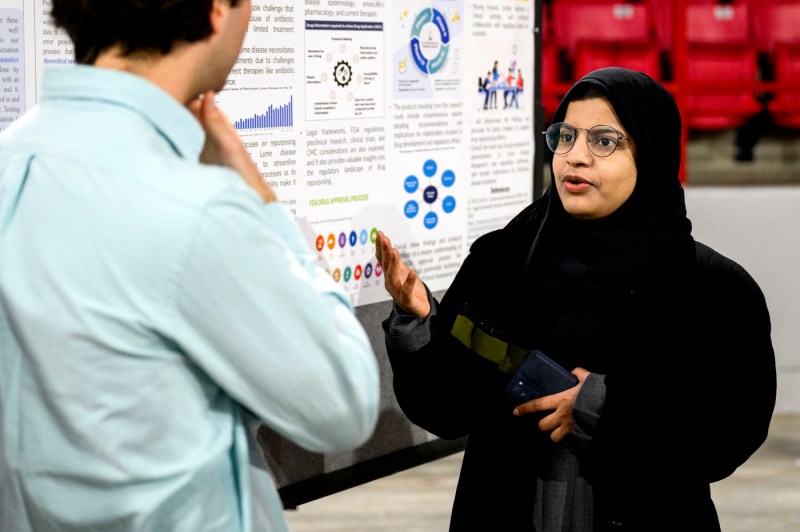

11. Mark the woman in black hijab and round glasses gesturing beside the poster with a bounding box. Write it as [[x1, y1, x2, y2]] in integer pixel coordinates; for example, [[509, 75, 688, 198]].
[[377, 68, 775, 532]]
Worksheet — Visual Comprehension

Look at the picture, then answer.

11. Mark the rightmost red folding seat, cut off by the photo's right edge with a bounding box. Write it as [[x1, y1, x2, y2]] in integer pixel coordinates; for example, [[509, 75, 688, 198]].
[[754, 0, 800, 128]]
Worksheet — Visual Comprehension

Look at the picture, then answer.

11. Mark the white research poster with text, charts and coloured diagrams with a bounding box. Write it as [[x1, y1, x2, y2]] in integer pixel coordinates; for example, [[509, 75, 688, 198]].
[[0, 0, 535, 305]]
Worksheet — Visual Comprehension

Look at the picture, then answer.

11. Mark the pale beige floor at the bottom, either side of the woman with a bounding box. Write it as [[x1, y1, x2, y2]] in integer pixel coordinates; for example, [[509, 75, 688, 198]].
[[286, 414, 800, 532]]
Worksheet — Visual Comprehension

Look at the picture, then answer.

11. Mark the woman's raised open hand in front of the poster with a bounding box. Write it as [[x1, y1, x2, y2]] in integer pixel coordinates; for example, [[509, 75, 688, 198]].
[[375, 231, 431, 318]]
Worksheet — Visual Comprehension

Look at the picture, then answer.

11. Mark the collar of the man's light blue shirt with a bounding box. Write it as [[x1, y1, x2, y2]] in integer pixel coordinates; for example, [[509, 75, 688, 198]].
[[41, 65, 205, 161]]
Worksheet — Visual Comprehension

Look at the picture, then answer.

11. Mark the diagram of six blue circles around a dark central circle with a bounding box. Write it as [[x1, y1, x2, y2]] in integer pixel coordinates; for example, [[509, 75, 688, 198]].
[[403, 159, 456, 229]]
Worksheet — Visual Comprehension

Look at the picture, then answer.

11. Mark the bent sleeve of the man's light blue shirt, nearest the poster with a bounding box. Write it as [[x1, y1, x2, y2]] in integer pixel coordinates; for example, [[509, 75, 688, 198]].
[[168, 188, 379, 452]]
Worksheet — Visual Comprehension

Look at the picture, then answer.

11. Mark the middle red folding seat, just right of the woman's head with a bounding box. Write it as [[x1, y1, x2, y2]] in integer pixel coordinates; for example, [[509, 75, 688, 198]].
[[685, 0, 761, 129]]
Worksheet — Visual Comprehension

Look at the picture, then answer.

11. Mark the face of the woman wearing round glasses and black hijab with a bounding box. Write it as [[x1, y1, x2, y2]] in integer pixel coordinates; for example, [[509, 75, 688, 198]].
[[553, 98, 636, 220]]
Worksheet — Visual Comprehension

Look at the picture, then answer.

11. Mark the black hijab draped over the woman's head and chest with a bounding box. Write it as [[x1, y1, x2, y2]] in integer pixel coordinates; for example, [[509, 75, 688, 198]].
[[507, 68, 694, 369]]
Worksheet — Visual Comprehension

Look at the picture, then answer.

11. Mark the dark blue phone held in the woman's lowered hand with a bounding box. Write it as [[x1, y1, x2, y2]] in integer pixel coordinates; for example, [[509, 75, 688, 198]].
[[506, 349, 578, 403]]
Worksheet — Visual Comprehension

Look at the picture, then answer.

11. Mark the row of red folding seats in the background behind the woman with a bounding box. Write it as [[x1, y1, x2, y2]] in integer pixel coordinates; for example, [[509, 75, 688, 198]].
[[541, 0, 800, 129]]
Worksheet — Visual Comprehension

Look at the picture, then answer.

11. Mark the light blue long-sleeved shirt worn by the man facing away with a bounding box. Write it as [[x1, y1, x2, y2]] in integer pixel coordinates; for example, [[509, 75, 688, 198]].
[[0, 66, 379, 532]]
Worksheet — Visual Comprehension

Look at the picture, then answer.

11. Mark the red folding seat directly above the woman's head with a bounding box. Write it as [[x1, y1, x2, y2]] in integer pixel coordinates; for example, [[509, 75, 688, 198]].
[[552, 0, 661, 79]]
